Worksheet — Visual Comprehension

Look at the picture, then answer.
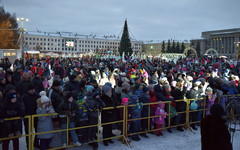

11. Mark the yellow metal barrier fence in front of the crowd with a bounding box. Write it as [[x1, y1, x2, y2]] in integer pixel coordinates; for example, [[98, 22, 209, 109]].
[[0, 95, 240, 150]]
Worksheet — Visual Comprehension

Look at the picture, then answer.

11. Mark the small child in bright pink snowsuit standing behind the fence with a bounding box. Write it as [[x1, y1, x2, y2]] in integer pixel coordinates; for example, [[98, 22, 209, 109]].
[[154, 101, 167, 136]]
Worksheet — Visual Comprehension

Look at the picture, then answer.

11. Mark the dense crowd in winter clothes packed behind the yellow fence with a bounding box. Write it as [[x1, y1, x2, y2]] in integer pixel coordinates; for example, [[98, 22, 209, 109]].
[[0, 57, 237, 150]]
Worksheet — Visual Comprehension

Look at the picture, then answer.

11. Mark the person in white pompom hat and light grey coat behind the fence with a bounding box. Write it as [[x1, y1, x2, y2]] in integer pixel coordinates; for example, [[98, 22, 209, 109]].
[[36, 91, 55, 150]]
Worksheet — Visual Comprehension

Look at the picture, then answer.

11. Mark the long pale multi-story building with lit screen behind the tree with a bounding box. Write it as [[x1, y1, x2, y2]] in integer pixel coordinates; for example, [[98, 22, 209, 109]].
[[24, 32, 142, 57]]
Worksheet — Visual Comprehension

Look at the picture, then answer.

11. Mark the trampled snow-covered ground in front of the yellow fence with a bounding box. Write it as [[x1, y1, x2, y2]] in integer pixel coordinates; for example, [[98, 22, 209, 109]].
[[8, 127, 240, 150]]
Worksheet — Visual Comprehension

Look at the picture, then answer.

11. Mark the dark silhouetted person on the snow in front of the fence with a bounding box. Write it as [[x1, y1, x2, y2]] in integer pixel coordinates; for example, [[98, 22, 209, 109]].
[[201, 104, 233, 150]]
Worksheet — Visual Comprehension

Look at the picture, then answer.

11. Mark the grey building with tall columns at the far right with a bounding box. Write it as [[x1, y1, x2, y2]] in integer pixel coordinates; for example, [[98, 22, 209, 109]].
[[191, 28, 240, 59]]
